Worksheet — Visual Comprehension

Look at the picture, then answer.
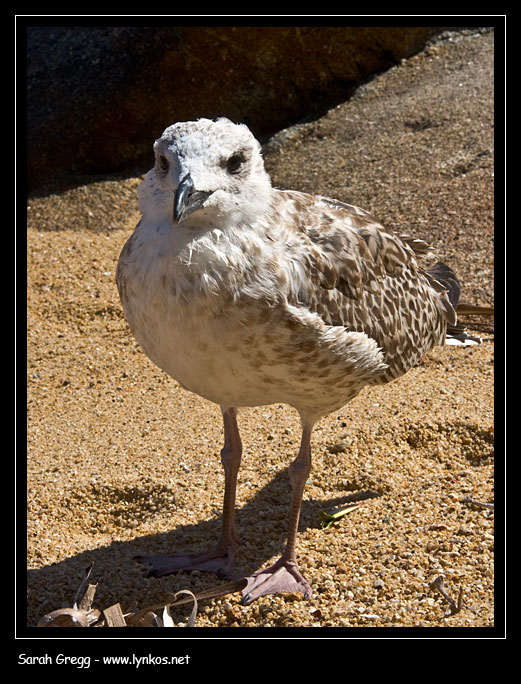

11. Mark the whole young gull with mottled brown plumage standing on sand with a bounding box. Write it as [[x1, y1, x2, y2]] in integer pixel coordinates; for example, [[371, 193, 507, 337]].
[[117, 118, 459, 605]]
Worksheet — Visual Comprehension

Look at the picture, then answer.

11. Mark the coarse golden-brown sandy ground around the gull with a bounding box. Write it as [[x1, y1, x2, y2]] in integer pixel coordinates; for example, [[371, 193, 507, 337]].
[[27, 33, 494, 627]]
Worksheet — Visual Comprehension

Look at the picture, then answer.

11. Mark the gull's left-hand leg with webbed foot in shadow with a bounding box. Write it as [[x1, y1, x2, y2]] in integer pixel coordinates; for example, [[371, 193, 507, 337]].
[[137, 407, 242, 577]]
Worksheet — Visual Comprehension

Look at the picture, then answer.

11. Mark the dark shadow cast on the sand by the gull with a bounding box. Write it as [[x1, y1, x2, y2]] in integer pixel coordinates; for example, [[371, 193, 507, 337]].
[[25, 469, 377, 627]]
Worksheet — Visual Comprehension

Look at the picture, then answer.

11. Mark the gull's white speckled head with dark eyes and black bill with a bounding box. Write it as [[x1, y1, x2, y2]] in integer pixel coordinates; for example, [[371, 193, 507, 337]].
[[144, 118, 271, 227]]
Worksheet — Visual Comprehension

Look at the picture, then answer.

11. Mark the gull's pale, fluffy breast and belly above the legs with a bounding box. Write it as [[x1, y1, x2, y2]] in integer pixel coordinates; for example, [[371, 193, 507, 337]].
[[117, 219, 386, 413]]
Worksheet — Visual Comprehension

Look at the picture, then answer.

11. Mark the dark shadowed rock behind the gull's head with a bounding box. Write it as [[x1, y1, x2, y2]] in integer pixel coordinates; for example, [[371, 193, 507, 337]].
[[27, 27, 441, 189]]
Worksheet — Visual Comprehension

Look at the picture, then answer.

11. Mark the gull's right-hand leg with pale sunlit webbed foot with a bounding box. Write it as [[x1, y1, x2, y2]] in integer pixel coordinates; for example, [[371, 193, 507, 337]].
[[241, 422, 313, 606]]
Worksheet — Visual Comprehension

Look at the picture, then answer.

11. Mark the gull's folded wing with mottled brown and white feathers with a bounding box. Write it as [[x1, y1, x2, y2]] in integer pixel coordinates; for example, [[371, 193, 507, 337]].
[[270, 191, 456, 380]]
